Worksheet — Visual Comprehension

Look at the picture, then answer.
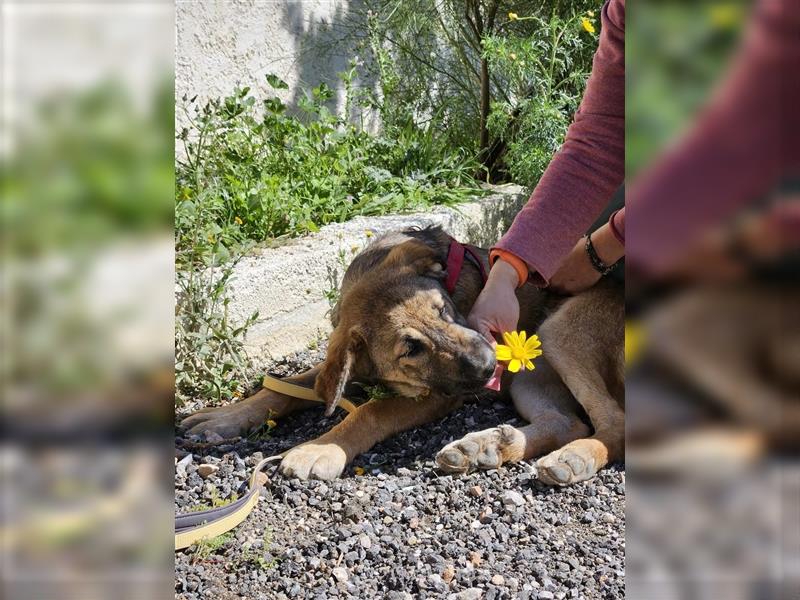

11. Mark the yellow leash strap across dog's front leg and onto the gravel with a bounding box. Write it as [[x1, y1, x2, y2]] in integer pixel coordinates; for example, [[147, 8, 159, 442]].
[[175, 375, 357, 550]]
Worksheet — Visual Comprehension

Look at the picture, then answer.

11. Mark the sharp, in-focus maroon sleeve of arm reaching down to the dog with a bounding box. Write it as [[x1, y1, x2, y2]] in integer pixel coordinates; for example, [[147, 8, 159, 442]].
[[495, 0, 625, 282]]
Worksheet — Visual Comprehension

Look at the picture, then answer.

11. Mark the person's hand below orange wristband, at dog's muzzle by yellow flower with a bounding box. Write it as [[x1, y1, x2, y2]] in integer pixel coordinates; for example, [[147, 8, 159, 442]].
[[467, 259, 519, 346]]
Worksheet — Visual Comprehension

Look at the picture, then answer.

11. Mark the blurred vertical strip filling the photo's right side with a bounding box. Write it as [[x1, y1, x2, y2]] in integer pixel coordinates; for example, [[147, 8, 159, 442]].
[[626, 2, 800, 600]]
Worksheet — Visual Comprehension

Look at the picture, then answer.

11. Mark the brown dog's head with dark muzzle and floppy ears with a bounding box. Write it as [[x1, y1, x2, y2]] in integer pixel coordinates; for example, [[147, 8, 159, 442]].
[[315, 239, 495, 412]]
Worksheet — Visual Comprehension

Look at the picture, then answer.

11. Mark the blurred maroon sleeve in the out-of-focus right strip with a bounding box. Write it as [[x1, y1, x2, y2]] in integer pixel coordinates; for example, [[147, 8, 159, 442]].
[[626, 0, 800, 273]]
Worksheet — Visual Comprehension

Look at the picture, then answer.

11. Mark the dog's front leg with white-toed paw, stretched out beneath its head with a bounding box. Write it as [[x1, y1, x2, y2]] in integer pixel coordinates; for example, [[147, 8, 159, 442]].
[[281, 398, 461, 480]]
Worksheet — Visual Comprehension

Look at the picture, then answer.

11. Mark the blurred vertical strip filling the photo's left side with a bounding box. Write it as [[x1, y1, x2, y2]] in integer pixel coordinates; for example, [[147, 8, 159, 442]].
[[0, 1, 174, 599]]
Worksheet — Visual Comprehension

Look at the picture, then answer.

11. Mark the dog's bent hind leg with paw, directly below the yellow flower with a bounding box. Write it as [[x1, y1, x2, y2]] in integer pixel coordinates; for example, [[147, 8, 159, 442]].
[[436, 361, 589, 473]]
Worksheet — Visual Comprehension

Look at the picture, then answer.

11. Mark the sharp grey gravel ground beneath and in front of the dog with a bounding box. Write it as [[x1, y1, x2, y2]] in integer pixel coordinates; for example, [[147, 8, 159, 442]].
[[175, 350, 625, 600]]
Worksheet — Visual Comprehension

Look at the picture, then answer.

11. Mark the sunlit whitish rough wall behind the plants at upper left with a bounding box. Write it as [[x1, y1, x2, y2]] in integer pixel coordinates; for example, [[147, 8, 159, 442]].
[[175, 0, 368, 124]]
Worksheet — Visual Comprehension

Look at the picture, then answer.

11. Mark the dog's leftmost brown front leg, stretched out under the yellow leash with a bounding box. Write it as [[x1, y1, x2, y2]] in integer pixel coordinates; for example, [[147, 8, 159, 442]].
[[179, 366, 320, 438]]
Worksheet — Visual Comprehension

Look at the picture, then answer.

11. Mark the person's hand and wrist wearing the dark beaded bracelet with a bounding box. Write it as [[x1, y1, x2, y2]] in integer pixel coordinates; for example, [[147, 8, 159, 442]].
[[550, 224, 625, 294]]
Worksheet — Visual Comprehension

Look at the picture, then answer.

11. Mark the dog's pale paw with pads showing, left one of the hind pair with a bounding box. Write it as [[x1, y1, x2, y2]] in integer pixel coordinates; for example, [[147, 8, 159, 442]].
[[436, 425, 525, 473]]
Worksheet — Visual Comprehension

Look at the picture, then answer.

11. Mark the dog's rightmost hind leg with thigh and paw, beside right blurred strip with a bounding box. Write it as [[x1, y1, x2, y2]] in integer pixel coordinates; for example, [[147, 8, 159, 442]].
[[536, 290, 625, 485]]
